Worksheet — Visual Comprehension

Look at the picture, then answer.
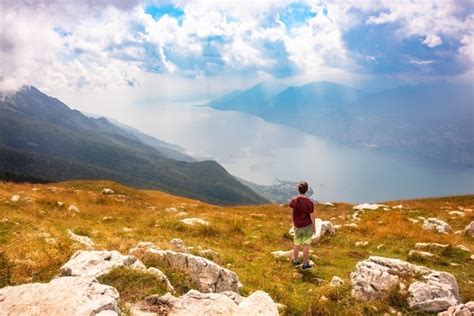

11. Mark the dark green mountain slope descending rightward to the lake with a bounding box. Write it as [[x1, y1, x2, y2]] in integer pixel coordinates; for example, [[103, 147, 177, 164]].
[[0, 87, 266, 204]]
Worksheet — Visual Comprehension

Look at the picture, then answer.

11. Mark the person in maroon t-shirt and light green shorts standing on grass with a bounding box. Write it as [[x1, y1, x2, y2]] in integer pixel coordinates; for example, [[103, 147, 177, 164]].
[[282, 181, 316, 270]]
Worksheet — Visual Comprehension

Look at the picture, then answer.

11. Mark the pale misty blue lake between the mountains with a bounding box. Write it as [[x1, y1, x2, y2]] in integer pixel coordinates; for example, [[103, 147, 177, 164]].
[[119, 102, 474, 203]]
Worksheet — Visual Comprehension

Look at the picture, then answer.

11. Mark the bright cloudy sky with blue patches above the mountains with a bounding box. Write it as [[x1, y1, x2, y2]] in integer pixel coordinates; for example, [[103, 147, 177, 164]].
[[0, 0, 474, 112]]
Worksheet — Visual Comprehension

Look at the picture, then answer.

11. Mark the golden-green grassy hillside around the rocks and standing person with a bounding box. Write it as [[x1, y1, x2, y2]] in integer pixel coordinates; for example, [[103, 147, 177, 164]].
[[0, 181, 474, 315]]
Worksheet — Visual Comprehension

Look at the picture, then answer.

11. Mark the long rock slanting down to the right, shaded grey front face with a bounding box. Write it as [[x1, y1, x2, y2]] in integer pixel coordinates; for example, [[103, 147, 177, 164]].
[[130, 242, 240, 293]]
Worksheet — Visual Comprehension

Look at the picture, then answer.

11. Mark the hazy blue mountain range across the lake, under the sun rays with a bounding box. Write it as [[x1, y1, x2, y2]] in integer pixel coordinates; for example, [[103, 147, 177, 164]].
[[209, 82, 474, 167]]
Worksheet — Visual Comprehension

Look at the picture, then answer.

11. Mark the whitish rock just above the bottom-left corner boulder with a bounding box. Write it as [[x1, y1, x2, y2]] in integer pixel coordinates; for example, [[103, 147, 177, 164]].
[[60, 250, 146, 278]]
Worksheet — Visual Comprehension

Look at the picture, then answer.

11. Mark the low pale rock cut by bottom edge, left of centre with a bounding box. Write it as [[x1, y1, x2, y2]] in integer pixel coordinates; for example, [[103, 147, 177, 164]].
[[136, 290, 278, 316]]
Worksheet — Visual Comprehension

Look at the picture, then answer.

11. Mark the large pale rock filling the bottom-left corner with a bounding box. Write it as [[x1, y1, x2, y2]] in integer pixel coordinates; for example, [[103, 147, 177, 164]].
[[0, 277, 120, 316]]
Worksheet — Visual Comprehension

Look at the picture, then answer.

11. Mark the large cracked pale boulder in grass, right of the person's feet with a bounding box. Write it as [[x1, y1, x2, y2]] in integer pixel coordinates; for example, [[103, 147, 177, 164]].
[[351, 256, 460, 312]]
